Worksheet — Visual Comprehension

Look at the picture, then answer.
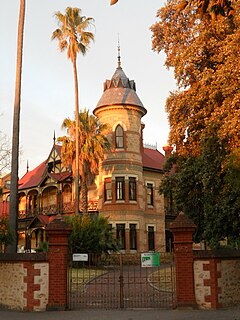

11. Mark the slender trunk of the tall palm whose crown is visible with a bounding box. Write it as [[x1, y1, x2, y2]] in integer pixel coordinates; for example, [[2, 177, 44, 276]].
[[73, 57, 79, 215]]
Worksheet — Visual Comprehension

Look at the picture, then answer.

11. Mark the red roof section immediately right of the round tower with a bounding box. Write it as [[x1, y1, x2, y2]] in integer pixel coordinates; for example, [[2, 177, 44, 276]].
[[142, 148, 165, 170]]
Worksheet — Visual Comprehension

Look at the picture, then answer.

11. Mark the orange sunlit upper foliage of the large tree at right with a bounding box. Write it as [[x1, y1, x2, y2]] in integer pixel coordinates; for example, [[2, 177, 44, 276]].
[[151, 0, 240, 155]]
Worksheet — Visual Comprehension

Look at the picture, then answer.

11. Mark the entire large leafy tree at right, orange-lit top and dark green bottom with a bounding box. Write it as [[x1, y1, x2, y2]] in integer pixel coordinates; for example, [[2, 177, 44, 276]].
[[151, 0, 240, 246]]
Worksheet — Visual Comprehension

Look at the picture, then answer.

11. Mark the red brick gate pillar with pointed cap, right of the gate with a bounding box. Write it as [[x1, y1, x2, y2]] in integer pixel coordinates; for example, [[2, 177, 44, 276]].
[[170, 212, 196, 307]]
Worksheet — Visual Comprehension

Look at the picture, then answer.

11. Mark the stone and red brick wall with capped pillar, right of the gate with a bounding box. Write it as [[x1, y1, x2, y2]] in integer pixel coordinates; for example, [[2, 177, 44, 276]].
[[171, 213, 240, 309]]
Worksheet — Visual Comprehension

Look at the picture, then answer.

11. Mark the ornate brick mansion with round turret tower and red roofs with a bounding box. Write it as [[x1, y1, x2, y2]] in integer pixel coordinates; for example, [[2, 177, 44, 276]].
[[0, 57, 175, 252]]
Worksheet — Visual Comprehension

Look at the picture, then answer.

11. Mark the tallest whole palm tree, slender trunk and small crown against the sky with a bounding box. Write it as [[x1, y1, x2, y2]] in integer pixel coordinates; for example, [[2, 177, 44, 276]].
[[52, 7, 94, 214]]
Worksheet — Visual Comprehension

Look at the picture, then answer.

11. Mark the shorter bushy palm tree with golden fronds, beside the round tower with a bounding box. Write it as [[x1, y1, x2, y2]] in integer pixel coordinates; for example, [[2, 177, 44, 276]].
[[58, 110, 110, 214]]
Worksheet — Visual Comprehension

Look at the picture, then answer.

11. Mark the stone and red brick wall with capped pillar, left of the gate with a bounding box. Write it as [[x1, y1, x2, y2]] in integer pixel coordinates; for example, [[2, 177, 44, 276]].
[[0, 218, 70, 311]]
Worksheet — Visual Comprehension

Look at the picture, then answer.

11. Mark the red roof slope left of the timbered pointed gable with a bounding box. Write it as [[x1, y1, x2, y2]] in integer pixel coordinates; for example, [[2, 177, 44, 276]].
[[18, 160, 46, 190]]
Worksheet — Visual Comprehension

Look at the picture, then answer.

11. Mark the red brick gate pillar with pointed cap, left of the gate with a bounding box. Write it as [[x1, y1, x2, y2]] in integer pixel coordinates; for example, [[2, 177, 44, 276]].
[[47, 217, 71, 310]]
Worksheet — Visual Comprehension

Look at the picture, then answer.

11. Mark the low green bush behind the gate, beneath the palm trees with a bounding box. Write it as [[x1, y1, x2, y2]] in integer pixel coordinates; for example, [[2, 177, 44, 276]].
[[67, 215, 117, 254]]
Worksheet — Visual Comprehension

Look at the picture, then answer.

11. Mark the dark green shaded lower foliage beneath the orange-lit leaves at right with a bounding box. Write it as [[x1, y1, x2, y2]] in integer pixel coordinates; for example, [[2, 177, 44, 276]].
[[159, 137, 240, 247]]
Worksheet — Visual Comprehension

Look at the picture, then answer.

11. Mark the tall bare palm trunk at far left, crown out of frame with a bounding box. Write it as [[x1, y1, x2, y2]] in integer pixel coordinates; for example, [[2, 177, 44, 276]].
[[7, 0, 25, 253]]
